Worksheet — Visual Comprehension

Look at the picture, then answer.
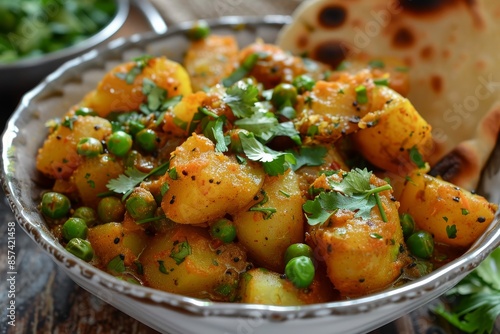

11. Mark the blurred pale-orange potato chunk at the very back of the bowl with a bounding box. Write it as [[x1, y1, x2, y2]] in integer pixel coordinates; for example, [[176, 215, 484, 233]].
[[184, 35, 238, 92]]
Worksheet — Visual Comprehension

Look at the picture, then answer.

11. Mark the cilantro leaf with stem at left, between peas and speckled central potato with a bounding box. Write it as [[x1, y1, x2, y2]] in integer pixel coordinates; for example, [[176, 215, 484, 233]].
[[106, 161, 170, 200]]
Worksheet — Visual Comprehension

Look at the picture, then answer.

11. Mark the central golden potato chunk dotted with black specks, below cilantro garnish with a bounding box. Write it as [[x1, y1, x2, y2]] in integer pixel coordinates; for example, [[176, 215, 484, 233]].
[[161, 134, 264, 224]]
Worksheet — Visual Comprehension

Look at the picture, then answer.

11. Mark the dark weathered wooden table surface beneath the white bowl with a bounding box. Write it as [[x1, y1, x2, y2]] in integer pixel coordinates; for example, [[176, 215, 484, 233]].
[[0, 1, 486, 334]]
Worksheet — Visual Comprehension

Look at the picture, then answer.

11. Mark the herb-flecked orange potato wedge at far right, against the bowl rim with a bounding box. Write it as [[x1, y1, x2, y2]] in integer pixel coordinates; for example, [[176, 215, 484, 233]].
[[399, 172, 497, 247]]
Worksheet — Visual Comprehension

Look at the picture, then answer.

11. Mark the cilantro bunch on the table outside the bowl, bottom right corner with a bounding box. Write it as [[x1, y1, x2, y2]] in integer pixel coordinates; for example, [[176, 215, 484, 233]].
[[434, 248, 500, 334]]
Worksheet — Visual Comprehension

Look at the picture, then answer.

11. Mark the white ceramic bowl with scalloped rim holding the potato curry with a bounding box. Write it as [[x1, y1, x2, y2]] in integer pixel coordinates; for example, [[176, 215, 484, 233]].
[[2, 16, 500, 334]]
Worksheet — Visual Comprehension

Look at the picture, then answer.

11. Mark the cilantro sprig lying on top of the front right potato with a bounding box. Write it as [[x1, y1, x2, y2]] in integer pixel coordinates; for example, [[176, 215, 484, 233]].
[[303, 168, 392, 225]]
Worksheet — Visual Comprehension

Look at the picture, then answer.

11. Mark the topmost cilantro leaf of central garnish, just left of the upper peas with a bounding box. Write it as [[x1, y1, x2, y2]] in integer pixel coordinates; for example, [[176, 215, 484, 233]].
[[222, 85, 259, 118]]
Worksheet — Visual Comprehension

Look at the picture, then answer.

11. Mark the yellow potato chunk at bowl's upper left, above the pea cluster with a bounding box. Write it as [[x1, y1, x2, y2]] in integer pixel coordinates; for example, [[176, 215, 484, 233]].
[[82, 57, 191, 117]]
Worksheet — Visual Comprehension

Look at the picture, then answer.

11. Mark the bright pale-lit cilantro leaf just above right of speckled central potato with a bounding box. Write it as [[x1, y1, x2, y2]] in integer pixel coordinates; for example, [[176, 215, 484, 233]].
[[239, 132, 296, 176]]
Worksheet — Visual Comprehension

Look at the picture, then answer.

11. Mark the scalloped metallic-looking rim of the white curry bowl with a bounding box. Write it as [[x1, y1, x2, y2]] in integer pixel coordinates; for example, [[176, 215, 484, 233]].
[[1, 15, 500, 319]]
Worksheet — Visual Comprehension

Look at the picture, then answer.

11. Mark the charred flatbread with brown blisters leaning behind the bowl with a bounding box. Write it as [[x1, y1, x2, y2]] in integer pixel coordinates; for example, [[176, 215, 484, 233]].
[[277, 0, 500, 190]]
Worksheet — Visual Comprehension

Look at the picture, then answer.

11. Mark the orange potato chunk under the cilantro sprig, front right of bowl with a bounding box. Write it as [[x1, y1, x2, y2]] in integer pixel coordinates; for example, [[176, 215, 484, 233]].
[[309, 175, 407, 297]]
